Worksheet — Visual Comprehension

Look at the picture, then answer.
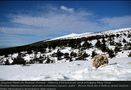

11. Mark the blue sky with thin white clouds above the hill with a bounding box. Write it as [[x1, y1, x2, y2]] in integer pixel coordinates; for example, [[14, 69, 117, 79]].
[[0, 1, 131, 47]]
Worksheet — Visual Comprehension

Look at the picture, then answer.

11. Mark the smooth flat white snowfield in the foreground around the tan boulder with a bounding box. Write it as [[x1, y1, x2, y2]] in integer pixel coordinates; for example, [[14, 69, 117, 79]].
[[0, 57, 131, 81]]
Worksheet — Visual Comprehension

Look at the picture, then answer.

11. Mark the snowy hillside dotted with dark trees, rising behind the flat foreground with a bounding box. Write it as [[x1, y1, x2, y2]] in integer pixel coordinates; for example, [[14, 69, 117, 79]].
[[0, 28, 131, 65]]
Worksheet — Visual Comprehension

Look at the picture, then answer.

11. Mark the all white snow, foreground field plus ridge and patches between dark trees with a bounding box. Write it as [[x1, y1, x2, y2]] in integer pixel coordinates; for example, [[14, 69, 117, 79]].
[[0, 28, 131, 81]]
